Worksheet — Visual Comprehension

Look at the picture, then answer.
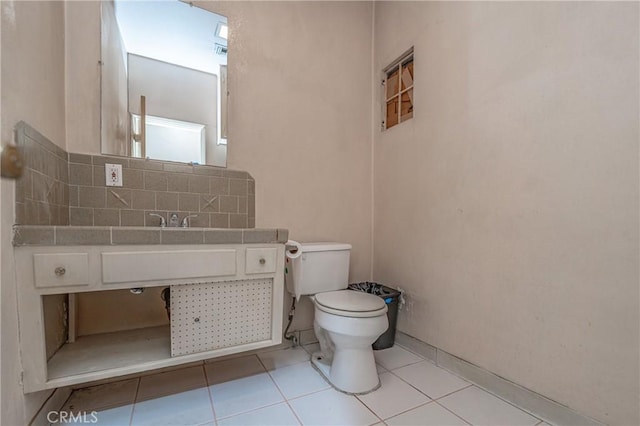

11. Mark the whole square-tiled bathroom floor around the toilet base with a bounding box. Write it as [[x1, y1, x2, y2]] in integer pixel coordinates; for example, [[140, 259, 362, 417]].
[[56, 344, 547, 426]]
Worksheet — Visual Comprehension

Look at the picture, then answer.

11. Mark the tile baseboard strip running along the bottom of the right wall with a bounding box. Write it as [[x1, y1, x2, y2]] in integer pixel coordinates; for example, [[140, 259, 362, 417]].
[[396, 332, 603, 426]]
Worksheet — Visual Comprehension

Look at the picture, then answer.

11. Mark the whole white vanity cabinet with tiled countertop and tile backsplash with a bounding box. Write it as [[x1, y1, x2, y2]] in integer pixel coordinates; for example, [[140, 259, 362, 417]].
[[13, 123, 288, 392]]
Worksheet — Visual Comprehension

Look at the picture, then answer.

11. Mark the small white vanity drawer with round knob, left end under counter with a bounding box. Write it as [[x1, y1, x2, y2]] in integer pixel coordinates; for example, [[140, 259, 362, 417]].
[[33, 253, 89, 288]]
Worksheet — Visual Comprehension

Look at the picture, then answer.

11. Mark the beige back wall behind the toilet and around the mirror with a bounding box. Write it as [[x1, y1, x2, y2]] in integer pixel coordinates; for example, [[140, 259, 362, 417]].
[[68, 2, 373, 328]]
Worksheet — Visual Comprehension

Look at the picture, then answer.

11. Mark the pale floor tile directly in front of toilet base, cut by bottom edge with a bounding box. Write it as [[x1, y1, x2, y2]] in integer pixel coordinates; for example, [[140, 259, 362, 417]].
[[289, 389, 380, 426]]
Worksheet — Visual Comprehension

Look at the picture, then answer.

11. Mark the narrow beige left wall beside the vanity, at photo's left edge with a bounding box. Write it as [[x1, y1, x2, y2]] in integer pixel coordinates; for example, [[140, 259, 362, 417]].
[[0, 1, 65, 425]]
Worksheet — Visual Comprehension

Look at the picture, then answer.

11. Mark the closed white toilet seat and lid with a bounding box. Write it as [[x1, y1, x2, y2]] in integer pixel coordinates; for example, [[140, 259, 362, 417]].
[[313, 290, 387, 318]]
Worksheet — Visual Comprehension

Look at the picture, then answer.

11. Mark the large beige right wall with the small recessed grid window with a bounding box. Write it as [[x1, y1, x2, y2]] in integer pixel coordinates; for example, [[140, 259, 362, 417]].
[[373, 2, 640, 425]]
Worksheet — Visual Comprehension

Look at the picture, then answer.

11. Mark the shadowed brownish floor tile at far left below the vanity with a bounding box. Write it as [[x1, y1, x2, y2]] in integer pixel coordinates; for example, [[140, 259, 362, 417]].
[[61, 379, 138, 413]]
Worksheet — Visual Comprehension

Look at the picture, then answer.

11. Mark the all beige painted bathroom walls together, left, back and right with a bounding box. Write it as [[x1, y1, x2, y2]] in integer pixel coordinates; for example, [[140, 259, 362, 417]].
[[0, 1, 640, 424]]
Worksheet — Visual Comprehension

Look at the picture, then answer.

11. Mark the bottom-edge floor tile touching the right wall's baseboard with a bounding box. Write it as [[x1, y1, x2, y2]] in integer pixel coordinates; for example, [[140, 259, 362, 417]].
[[438, 386, 540, 426]]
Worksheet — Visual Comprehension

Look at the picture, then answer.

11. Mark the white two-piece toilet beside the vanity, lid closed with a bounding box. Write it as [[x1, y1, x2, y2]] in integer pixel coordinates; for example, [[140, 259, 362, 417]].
[[285, 243, 389, 394]]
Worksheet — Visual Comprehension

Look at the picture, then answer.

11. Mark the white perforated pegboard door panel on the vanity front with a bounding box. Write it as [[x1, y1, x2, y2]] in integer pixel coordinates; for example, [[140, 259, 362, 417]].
[[171, 278, 273, 356]]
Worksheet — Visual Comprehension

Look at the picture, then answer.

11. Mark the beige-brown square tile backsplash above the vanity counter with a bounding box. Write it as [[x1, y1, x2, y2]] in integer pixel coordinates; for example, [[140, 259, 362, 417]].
[[16, 123, 255, 228]]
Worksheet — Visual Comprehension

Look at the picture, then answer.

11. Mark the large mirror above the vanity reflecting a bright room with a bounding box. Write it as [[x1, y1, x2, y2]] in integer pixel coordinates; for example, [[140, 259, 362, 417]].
[[101, 0, 228, 167]]
